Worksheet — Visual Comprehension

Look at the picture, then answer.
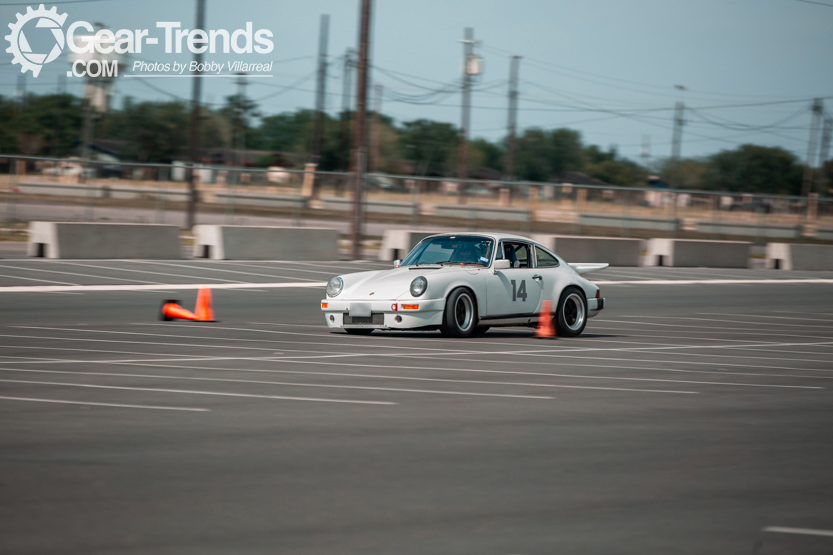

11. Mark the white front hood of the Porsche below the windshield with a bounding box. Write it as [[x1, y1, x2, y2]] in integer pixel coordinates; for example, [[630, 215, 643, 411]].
[[338, 266, 473, 301]]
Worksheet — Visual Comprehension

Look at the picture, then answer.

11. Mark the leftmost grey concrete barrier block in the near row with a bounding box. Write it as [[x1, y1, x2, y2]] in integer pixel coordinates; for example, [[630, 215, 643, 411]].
[[28, 222, 182, 260]]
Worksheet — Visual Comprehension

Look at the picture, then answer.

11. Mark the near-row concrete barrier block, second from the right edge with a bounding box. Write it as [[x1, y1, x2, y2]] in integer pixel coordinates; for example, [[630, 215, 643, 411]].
[[647, 239, 752, 268]]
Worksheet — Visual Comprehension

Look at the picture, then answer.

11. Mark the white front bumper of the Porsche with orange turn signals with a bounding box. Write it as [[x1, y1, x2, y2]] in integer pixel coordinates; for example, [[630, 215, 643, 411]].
[[321, 299, 445, 330]]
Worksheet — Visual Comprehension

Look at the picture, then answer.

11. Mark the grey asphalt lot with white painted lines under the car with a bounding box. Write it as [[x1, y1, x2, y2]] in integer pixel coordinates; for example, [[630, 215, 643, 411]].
[[0, 260, 833, 555]]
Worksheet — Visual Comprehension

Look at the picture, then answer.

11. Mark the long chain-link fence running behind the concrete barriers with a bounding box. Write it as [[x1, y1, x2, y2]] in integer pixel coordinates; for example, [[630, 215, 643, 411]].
[[0, 156, 833, 241]]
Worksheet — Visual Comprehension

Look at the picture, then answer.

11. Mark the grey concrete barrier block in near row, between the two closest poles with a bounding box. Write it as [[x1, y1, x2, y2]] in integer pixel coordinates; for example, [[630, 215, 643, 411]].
[[194, 225, 338, 260]]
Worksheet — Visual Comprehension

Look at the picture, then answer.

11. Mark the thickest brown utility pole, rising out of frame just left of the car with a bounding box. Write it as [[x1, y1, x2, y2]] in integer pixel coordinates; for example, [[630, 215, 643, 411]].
[[350, 0, 371, 260]]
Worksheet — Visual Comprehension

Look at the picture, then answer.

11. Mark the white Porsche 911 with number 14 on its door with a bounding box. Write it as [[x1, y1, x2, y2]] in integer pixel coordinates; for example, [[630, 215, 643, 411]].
[[321, 233, 608, 337]]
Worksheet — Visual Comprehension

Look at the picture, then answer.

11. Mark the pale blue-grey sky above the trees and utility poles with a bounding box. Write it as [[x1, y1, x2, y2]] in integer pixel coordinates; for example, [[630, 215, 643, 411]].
[[0, 0, 833, 165]]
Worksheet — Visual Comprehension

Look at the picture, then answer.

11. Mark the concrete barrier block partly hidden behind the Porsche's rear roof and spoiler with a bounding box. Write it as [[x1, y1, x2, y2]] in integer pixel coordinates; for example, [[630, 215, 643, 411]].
[[532, 234, 644, 266]]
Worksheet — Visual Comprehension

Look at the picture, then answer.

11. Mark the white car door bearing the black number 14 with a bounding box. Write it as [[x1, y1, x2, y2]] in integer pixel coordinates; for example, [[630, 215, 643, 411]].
[[486, 240, 543, 318]]
